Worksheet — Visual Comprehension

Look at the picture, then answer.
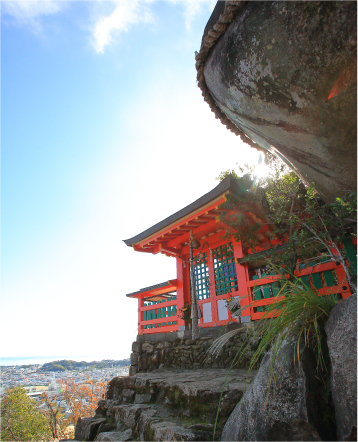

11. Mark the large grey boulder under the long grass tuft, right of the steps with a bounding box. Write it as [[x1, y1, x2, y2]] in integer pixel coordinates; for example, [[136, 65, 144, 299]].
[[221, 343, 336, 442]]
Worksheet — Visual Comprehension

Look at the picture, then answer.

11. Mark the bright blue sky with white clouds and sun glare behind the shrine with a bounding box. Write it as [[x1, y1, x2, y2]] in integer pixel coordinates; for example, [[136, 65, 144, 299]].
[[0, 0, 258, 358]]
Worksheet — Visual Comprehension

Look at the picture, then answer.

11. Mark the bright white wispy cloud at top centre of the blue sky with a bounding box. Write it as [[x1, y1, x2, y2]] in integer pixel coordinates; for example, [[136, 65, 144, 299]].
[[93, 0, 153, 53]]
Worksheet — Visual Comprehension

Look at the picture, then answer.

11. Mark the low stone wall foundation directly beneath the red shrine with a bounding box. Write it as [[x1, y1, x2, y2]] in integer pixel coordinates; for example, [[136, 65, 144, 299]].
[[129, 324, 258, 376]]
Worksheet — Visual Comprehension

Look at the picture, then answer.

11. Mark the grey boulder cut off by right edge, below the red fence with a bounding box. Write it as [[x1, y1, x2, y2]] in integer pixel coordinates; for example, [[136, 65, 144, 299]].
[[325, 294, 358, 442]]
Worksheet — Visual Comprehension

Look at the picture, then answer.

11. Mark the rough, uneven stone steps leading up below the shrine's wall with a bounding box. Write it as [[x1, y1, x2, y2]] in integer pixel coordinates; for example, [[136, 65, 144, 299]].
[[75, 369, 256, 442]]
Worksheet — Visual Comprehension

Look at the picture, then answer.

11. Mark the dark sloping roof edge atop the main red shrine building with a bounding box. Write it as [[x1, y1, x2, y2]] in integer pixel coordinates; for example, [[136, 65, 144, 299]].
[[124, 175, 243, 247]]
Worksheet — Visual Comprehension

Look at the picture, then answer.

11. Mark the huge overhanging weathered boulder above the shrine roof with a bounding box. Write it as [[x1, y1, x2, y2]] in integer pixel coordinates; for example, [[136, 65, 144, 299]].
[[204, 0, 358, 200]]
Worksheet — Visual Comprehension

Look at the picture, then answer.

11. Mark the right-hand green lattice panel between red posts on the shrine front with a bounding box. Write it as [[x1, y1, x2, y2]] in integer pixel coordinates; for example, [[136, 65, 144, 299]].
[[213, 244, 238, 296]]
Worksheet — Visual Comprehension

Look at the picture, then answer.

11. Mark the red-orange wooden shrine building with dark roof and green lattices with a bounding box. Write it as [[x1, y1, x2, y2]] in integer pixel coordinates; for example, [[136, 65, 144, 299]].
[[124, 175, 358, 334]]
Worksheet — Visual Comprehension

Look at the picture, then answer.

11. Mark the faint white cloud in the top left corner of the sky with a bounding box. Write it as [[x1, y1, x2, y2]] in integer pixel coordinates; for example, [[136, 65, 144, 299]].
[[0, 0, 67, 22]]
